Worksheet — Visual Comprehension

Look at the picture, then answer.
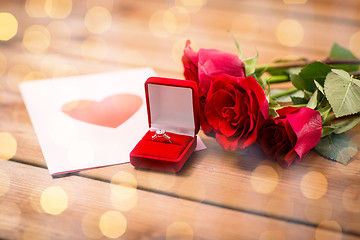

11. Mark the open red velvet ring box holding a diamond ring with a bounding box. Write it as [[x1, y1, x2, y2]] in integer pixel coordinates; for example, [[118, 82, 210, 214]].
[[130, 77, 200, 172]]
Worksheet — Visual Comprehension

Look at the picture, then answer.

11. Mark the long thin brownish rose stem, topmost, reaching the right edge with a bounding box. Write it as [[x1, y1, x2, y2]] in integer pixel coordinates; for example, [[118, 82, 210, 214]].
[[255, 58, 360, 72]]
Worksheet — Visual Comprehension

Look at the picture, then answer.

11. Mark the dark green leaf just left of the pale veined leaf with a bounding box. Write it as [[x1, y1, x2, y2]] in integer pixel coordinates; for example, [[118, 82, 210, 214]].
[[296, 62, 331, 92]]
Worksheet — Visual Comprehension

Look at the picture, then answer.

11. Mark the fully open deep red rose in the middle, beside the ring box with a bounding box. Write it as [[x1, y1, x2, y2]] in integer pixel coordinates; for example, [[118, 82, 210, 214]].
[[204, 74, 269, 150]]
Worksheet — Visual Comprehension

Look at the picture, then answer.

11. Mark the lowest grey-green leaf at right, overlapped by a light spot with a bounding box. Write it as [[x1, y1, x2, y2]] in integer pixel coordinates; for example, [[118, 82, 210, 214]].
[[315, 133, 358, 165]]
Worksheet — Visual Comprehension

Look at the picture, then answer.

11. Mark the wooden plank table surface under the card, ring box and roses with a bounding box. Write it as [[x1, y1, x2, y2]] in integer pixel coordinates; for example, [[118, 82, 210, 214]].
[[0, 0, 360, 240]]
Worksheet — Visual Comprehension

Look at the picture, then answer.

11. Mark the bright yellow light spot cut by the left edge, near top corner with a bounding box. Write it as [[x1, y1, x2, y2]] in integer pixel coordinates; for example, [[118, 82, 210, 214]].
[[0, 12, 18, 41]]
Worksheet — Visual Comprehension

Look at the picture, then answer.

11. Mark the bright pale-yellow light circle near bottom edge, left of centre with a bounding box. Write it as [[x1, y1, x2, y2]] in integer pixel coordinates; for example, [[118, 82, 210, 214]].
[[99, 211, 127, 238]]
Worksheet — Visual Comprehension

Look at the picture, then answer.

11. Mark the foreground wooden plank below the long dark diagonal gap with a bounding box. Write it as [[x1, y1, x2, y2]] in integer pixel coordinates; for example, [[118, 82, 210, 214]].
[[0, 161, 357, 239]]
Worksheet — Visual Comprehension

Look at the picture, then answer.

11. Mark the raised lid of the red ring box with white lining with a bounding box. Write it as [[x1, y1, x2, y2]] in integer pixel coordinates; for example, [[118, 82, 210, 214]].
[[145, 77, 200, 137]]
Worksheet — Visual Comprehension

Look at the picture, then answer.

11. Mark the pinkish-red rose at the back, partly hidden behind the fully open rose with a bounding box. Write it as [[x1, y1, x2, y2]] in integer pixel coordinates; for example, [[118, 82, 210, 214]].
[[182, 40, 245, 97]]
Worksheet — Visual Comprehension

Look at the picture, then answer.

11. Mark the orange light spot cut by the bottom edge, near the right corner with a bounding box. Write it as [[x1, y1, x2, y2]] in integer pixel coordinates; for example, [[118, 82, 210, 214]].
[[315, 220, 342, 240]]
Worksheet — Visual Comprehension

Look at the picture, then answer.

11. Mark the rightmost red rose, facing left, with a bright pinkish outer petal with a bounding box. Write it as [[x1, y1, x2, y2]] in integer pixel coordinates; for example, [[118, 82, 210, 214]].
[[260, 107, 322, 168]]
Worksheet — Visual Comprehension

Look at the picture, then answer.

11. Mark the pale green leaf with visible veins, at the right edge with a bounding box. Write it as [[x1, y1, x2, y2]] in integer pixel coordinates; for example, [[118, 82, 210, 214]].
[[324, 69, 360, 117]]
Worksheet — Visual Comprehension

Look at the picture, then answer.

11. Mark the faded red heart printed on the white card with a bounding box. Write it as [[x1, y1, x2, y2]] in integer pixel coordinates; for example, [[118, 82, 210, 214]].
[[61, 94, 143, 128]]
